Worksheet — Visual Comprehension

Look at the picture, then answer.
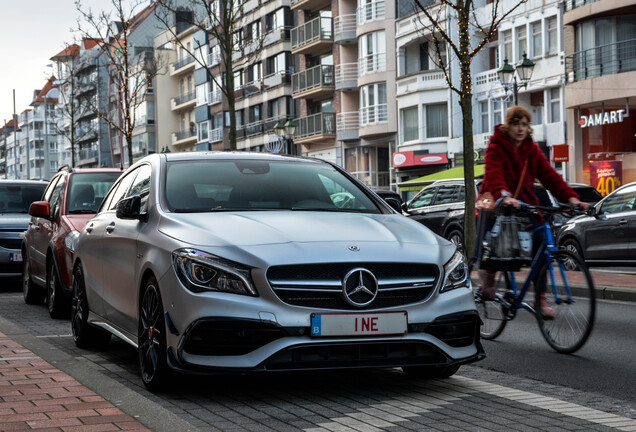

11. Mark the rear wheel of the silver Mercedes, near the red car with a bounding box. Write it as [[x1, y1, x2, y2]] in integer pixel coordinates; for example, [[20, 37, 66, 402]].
[[71, 266, 110, 349]]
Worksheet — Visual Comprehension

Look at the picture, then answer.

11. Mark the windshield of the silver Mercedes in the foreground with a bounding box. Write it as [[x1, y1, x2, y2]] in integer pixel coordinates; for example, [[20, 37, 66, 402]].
[[165, 160, 380, 213]]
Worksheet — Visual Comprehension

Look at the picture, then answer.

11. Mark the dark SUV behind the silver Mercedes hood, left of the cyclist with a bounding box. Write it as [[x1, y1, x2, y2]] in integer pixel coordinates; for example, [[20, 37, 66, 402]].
[[403, 179, 474, 245]]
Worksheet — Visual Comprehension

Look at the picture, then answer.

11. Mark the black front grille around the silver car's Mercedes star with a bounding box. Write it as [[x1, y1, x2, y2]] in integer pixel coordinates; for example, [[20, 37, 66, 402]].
[[267, 263, 438, 310]]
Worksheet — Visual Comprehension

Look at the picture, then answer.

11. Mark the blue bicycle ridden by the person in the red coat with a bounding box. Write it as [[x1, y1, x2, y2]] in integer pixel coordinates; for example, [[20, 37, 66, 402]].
[[473, 204, 596, 354]]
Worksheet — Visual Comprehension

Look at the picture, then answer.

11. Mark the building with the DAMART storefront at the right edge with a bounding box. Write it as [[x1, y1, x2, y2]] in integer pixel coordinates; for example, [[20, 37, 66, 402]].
[[562, 0, 636, 189]]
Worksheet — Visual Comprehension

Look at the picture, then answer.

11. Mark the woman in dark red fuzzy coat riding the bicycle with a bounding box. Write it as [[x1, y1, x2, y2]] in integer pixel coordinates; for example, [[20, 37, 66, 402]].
[[479, 105, 589, 319]]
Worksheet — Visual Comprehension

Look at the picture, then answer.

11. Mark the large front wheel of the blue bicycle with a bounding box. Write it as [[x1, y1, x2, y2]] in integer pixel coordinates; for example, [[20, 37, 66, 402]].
[[534, 249, 596, 354]]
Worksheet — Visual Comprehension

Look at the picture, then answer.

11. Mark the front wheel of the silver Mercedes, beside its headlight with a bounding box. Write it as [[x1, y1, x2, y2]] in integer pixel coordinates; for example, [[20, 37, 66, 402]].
[[137, 277, 170, 391]]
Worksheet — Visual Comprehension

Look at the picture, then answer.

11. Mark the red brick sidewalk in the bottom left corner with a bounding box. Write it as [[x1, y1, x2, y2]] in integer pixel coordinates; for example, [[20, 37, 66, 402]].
[[0, 333, 150, 432]]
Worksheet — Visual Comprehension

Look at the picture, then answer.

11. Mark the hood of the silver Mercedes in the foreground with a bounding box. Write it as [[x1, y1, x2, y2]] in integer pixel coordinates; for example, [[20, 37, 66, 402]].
[[159, 211, 439, 247]]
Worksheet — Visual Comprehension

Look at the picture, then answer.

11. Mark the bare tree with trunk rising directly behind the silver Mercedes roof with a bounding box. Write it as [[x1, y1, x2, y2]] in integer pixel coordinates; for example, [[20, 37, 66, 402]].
[[158, 0, 264, 150]]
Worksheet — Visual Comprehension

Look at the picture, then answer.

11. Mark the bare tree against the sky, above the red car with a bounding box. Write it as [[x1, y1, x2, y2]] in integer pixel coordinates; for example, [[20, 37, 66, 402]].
[[75, 0, 159, 164]]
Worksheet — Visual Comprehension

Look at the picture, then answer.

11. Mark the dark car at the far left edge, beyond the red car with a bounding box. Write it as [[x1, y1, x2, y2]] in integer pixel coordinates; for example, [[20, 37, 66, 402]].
[[0, 180, 46, 278]]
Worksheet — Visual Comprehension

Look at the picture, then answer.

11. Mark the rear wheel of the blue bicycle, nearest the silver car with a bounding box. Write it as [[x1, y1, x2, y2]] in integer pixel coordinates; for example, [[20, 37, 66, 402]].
[[473, 272, 510, 340]]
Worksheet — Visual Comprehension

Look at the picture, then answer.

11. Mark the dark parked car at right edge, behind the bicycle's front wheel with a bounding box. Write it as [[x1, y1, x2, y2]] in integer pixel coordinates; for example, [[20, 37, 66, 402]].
[[557, 182, 636, 265]]
